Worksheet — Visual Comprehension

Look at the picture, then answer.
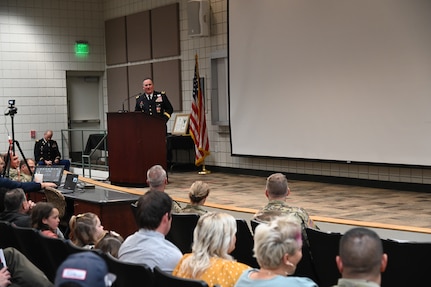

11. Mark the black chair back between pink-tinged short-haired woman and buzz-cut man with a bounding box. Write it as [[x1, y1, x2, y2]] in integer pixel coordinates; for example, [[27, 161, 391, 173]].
[[305, 227, 341, 287]]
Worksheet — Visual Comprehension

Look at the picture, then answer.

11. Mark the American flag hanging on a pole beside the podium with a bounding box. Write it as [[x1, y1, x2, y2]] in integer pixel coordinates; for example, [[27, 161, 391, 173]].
[[190, 55, 210, 166]]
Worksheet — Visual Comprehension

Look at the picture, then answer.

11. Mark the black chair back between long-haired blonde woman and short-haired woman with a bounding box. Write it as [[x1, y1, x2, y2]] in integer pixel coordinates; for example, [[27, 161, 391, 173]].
[[230, 218, 259, 268]]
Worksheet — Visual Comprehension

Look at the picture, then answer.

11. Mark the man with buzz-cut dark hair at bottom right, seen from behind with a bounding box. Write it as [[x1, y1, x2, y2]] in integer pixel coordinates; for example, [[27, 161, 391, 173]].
[[335, 227, 388, 287]]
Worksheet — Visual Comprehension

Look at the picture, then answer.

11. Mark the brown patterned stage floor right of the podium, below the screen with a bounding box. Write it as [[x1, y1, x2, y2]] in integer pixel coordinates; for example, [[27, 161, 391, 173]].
[[162, 171, 431, 228]]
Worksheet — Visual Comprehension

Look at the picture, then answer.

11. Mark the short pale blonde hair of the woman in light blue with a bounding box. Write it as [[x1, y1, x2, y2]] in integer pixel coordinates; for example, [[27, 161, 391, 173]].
[[253, 216, 302, 269]]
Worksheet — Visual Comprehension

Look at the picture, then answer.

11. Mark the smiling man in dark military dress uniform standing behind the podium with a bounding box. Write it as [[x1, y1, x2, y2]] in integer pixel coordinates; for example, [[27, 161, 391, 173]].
[[135, 78, 174, 122]]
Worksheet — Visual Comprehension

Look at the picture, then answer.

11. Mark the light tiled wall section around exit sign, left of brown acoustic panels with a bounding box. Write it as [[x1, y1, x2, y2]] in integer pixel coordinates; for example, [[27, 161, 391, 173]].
[[0, 0, 105, 157]]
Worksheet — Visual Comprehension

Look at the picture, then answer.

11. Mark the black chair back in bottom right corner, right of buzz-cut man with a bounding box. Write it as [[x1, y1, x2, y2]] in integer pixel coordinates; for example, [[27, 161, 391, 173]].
[[381, 239, 431, 287]]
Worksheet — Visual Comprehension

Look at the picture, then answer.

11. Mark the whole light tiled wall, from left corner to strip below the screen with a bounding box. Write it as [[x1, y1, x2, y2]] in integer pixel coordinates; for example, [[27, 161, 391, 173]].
[[0, 0, 431, 184]]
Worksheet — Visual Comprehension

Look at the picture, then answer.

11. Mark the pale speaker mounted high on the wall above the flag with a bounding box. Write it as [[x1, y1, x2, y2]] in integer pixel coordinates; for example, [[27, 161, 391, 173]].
[[187, 0, 210, 37]]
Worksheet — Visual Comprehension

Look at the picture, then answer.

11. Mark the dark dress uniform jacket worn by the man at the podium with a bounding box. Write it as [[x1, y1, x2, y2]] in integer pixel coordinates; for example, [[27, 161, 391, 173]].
[[135, 91, 174, 121]]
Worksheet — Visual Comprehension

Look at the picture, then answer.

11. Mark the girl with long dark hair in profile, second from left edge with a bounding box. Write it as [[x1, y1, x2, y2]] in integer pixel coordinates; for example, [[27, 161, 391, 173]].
[[31, 204, 64, 238]]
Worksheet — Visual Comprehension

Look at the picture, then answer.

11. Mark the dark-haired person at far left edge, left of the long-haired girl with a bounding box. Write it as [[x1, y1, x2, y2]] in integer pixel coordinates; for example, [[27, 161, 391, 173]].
[[0, 188, 35, 227]]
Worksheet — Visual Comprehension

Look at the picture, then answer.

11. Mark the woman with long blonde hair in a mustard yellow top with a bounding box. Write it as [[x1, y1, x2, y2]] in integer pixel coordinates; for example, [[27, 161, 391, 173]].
[[172, 212, 250, 287]]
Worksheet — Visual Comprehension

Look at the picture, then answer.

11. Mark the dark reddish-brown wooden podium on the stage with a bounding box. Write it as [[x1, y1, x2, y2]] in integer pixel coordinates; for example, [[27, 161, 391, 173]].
[[107, 112, 167, 187]]
